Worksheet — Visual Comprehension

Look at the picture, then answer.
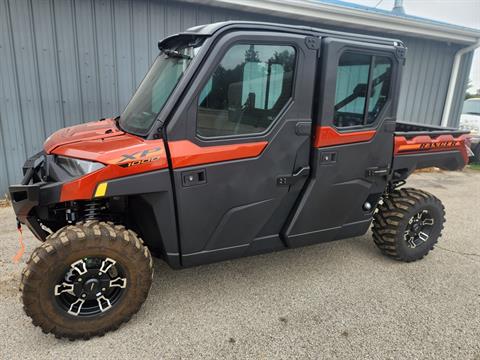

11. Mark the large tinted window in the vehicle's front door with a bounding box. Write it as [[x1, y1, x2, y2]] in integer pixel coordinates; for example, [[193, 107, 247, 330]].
[[197, 44, 295, 137]]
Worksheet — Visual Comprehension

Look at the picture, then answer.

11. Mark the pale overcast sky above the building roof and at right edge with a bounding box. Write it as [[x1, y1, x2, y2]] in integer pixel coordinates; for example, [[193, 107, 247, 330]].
[[345, 0, 480, 92]]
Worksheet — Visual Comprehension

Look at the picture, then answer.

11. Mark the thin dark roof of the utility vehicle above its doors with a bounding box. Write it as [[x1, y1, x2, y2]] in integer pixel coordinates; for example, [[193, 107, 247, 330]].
[[183, 20, 403, 45]]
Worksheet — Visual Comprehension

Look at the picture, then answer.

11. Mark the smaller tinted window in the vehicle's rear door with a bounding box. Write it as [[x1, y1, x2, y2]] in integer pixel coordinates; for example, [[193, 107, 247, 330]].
[[334, 52, 392, 128]]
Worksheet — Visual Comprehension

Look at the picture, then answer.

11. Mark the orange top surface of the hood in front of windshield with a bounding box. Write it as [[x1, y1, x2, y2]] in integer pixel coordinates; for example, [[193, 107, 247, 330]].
[[43, 118, 125, 154]]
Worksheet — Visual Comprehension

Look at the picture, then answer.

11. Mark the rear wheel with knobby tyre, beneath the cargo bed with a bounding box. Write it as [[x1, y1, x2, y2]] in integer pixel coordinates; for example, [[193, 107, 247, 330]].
[[372, 188, 445, 262]]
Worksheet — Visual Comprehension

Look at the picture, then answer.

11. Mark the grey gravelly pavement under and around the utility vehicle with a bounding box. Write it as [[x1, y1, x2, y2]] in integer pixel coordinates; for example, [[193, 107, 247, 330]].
[[0, 170, 480, 360]]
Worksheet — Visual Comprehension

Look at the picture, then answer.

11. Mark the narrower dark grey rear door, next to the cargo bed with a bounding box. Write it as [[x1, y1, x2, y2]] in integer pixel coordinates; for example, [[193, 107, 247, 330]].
[[285, 38, 402, 246]]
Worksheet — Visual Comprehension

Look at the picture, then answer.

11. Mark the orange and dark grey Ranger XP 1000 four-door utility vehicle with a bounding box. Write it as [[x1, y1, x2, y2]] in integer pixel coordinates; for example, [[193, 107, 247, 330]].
[[10, 22, 467, 339]]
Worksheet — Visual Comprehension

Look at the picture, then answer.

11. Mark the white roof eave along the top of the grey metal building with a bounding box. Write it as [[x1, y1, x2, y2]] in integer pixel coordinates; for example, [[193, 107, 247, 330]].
[[182, 0, 480, 44]]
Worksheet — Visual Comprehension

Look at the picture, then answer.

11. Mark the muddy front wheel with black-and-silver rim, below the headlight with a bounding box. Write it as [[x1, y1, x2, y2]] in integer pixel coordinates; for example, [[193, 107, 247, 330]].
[[21, 221, 153, 340]]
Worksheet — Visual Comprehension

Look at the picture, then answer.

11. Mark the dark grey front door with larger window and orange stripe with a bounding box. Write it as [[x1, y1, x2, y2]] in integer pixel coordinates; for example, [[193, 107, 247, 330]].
[[167, 31, 317, 266]]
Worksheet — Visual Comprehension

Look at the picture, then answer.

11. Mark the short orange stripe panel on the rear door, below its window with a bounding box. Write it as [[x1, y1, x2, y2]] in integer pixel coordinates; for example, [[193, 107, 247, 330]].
[[313, 126, 376, 148]]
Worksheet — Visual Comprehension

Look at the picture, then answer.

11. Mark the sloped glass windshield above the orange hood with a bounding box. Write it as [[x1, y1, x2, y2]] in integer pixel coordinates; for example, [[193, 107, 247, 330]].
[[119, 37, 203, 135]]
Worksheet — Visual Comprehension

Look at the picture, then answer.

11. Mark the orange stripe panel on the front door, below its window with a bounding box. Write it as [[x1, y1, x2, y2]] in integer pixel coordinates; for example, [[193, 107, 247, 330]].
[[168, 140, 268, 169]]
